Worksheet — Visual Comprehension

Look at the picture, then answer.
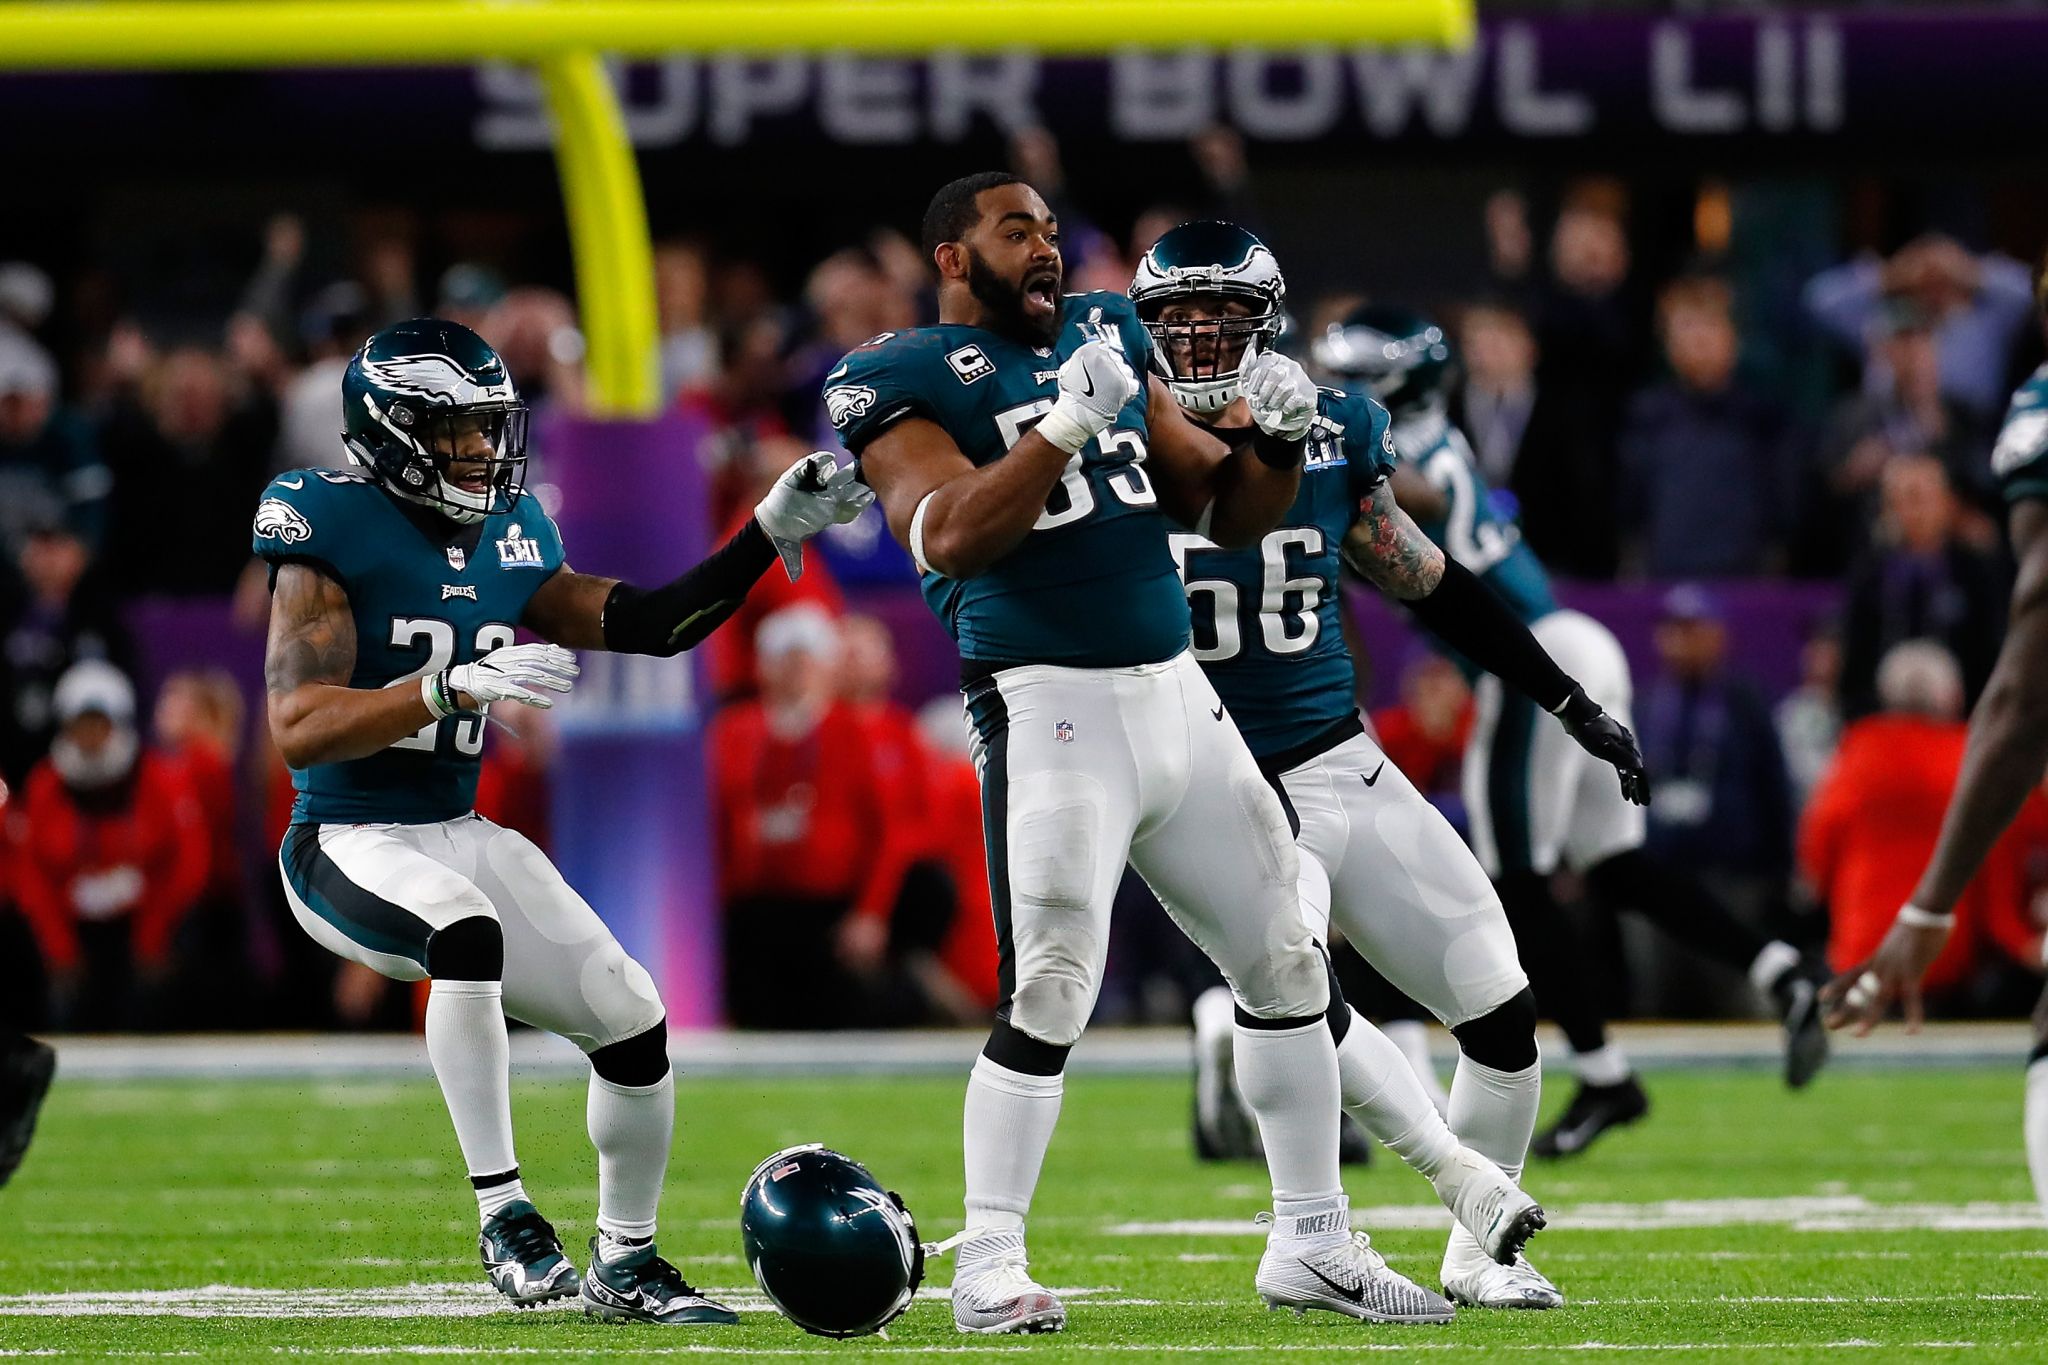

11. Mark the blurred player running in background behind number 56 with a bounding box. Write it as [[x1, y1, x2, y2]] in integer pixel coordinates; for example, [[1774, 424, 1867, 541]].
[[1315, 305, 1827, 1156]]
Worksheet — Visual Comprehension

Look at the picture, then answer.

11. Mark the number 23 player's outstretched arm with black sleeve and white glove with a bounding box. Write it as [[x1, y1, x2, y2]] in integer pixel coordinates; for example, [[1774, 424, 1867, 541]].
[[520, 450, 874, 657]]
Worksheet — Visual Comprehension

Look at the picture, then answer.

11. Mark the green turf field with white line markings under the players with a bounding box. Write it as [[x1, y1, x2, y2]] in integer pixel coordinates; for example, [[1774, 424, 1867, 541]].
[[0, 1066, 2048, 1361]]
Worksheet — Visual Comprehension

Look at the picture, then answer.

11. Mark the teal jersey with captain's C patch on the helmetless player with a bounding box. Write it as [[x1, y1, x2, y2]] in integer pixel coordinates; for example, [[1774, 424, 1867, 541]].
[[825, 293, 1188, 667]]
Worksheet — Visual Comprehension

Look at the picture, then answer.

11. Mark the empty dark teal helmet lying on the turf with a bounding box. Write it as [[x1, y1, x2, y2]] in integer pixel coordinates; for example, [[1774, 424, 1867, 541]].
[[739, 1142, 924, 1336]]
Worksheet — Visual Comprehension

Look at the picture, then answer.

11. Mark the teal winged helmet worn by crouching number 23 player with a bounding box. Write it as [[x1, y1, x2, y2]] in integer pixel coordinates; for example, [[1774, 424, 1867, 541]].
[[342, 317, 526, 524]]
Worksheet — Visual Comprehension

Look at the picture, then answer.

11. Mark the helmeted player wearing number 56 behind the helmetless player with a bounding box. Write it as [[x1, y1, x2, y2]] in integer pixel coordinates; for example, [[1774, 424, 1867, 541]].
[[1130, 223, 1645, 1308]]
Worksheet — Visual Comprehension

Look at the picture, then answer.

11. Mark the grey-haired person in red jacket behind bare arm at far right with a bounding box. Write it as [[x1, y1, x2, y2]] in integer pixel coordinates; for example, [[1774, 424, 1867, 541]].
[[1798, 641, 2032, 999]]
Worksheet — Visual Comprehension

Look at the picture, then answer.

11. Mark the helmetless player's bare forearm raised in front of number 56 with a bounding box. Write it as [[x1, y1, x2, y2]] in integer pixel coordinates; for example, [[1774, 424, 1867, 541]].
[[1145, 377, 1300, 551]]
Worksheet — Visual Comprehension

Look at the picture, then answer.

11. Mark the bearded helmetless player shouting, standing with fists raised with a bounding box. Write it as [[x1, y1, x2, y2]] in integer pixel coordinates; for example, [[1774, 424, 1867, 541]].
[[839, 174, 1452, 1332]]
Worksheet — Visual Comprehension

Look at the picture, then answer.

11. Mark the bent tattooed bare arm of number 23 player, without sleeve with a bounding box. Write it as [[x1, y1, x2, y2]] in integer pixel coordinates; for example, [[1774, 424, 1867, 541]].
[[264, 565, 434, 767]]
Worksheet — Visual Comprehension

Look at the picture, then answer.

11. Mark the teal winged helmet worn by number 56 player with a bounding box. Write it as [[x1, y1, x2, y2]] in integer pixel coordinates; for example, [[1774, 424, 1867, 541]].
[[1130, 221, 1286, 415]]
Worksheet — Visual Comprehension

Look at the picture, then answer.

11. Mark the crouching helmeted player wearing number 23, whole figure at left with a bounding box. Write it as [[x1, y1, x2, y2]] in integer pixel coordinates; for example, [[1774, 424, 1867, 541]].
[[254, 319, 870, 1324]]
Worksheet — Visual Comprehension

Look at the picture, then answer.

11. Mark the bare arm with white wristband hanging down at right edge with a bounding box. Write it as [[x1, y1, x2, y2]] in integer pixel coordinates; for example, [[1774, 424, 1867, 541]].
[[1823, 497, 2048, 1036]]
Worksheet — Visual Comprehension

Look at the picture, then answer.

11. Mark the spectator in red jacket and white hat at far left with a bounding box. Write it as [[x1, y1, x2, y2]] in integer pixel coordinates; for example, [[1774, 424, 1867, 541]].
[[16, 661, 209, 1029]]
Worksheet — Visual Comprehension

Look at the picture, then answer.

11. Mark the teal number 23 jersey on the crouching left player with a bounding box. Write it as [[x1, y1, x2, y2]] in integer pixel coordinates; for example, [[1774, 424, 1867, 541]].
[[254, 469, 561, 825]]
